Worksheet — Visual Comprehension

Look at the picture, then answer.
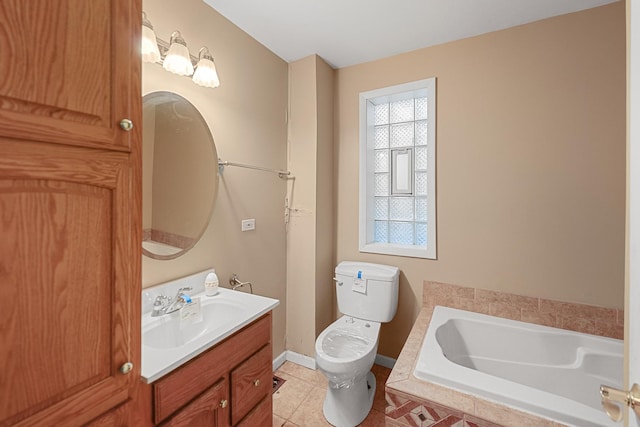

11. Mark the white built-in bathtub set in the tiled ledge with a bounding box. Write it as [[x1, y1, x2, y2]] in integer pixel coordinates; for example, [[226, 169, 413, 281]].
[[414, 306, 624, 427]]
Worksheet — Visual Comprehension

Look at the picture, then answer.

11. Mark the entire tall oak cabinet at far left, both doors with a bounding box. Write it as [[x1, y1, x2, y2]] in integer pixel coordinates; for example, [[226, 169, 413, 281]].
[[0, 0, 142, 427]]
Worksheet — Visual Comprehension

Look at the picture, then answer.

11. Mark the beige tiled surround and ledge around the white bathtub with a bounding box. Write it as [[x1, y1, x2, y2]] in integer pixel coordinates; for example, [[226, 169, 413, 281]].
[[386, 282, 624, 427]]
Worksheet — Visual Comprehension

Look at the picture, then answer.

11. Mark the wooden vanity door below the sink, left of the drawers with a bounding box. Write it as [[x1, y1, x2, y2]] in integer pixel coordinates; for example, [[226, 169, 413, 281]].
[[161, 378, 229, 427]]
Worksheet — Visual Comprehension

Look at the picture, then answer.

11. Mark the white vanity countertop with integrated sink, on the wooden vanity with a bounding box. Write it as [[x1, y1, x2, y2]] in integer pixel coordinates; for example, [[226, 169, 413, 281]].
[[141, 288, 280, 383]]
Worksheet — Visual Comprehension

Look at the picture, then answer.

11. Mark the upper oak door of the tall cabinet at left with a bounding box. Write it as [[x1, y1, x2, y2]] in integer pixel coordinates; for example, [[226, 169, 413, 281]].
[[0, 0, 142, 150]]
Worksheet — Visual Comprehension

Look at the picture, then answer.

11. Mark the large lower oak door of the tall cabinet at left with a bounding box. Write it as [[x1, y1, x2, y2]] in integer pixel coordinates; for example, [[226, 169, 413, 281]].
[[0, 139, 140, 426]]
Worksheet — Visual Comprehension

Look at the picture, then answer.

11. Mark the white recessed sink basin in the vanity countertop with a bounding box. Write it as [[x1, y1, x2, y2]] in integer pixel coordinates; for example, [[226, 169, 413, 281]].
[[142, 300, 246, 349]]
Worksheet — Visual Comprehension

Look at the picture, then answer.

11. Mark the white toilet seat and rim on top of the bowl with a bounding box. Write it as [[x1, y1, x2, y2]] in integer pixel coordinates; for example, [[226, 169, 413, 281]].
[[315, 316, 380, 363]]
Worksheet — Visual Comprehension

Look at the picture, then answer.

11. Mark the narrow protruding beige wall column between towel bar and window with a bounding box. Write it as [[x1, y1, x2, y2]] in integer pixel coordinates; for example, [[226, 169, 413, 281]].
[[287, 55, 335, 357]]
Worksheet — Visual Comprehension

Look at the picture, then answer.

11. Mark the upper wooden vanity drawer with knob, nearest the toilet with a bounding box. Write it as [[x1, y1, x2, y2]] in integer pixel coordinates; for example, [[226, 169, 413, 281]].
[[231, 345, 273, 424]]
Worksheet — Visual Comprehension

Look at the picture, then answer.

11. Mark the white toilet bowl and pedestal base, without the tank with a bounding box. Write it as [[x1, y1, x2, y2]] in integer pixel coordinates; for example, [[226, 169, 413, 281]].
[[315, 315, 380, 427]]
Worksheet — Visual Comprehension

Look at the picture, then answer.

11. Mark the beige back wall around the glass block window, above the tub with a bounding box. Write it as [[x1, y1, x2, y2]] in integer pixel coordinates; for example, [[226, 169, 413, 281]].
[[338, 2, 626, 357]]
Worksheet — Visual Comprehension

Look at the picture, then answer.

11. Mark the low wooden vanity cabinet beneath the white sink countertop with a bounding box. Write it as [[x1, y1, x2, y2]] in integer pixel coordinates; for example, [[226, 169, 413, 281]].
[[147, 312, 273, 426]]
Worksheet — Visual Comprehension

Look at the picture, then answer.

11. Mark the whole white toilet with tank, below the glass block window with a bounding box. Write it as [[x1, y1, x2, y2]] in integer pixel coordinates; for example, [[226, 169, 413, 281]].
[[315, 261, 400, 427]]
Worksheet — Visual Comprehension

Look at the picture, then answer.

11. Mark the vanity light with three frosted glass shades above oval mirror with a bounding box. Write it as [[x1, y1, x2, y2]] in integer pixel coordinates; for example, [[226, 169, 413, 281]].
[[141, 12, 220, 88]]
